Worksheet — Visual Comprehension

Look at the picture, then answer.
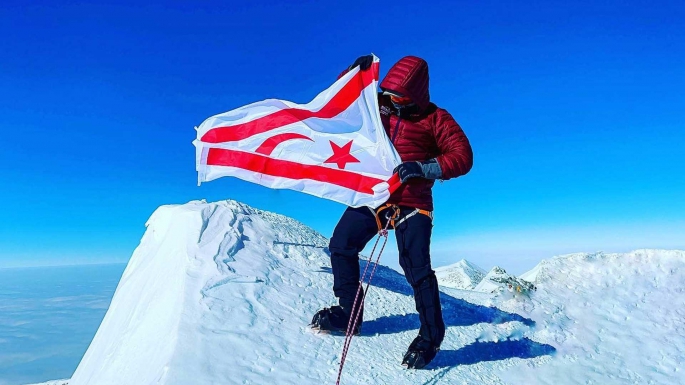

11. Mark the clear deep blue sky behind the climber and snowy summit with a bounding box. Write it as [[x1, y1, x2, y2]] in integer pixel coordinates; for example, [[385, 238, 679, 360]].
[[0, 1, 685, 272]]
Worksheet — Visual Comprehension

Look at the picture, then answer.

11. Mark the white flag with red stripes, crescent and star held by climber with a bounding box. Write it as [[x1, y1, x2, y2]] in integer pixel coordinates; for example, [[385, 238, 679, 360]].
[[193, 56, 401, 207]]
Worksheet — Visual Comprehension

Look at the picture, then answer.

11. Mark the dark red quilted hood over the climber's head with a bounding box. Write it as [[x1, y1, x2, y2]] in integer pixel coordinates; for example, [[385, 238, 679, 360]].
[[381, 56, 430, 111]]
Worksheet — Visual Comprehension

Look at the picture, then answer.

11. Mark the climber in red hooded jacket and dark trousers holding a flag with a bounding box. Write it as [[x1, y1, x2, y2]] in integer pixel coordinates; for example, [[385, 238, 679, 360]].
[[312, 55, 473, 369]]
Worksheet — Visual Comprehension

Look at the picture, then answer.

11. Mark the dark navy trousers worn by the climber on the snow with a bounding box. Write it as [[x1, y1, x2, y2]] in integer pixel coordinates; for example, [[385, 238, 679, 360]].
[[329, 207, 445, 345]]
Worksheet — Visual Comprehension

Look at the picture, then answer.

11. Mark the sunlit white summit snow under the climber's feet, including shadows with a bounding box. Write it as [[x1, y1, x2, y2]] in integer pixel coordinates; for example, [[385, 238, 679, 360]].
[[51, 201, 685, 385]]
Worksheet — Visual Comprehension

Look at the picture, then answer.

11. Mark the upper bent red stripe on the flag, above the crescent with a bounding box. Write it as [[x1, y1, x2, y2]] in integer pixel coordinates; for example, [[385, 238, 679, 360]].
[[200, 63, 379, 143]]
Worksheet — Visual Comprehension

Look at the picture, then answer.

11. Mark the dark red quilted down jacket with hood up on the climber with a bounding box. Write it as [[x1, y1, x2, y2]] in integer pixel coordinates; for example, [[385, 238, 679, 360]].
[[378, 56, 473, 211]]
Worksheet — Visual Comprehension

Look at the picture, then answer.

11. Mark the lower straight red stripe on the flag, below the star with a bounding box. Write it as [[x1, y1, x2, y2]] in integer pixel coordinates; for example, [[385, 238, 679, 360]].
[[207, 148, 385, 195]]
